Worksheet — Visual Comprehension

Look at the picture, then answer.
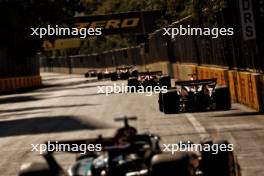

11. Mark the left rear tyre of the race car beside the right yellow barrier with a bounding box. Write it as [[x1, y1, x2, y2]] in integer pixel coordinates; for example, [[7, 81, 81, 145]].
[[162, 89, 180, 114]]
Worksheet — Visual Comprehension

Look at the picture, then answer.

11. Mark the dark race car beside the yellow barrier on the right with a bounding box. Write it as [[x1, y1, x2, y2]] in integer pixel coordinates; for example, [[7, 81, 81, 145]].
[[158, 79, 231, 114]]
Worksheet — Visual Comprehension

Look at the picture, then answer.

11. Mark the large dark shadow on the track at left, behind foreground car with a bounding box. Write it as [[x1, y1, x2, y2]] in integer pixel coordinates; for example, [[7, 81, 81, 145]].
[[0, 116, 110, 137]]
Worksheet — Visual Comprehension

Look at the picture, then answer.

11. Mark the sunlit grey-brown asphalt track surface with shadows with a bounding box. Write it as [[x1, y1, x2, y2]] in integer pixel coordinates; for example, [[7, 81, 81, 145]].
[[0, 73, 264, 176]]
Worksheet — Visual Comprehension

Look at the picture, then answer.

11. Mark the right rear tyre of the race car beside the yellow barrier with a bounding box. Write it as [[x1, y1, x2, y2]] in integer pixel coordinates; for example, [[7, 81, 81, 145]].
[[214, 87, 231, 110]]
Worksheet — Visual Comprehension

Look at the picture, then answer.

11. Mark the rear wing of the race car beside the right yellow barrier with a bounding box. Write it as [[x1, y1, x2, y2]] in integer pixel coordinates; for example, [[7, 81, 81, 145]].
[[175, 78, 217, 86]]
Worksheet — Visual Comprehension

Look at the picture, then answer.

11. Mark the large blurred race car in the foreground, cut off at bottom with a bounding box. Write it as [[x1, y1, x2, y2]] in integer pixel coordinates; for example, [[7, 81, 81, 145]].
[[19, 118, 240, 176]]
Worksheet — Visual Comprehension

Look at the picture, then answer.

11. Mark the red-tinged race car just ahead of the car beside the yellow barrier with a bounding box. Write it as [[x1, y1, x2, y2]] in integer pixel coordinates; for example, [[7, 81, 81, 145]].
[[127, 71, 171, 89]]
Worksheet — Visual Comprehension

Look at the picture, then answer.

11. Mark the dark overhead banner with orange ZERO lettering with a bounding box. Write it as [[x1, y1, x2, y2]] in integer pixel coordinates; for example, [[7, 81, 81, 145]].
[[75, 11, 162, 35]]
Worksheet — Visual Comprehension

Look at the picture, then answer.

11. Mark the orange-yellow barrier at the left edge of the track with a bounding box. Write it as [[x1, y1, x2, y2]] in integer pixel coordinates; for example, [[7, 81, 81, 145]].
[[0, 76, 42, 92]]
